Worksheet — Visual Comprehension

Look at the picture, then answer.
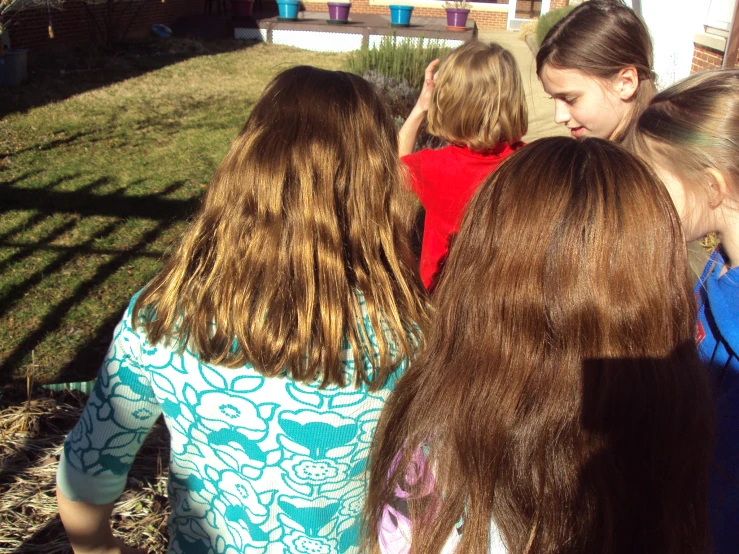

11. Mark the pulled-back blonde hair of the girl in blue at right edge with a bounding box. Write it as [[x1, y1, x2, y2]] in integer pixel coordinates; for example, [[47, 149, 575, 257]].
[[634, 69, 739, 200]]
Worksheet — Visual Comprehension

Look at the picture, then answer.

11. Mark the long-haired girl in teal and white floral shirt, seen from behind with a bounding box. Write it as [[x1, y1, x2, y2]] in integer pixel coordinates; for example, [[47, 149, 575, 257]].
[[57, 67, 427, 554]]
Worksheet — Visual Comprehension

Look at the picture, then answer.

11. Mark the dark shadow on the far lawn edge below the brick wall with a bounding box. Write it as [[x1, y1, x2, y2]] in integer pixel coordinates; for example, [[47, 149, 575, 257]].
[[0, 31, 258, 119]]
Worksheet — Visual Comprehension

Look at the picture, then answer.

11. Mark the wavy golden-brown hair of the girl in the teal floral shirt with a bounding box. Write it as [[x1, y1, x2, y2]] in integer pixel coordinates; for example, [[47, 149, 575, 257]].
[[133, 66, 427, 388]]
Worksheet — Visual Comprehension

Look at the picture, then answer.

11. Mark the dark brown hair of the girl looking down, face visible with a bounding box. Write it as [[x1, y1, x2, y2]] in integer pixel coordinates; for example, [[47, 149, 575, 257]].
[[536, 0, 656, 142]]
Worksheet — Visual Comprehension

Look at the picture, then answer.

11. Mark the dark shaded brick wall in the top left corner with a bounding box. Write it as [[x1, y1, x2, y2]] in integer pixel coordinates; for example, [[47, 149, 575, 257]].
[[8, 0, 204, 52]]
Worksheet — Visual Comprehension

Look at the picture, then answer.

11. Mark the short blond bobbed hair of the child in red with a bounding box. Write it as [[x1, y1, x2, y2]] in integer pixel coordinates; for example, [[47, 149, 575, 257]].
[[427, 41, 528, 151]]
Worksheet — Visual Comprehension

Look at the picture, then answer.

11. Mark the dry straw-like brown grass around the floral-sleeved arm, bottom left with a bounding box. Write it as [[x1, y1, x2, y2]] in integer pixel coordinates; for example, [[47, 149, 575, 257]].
[[0, 389, 169, 554]]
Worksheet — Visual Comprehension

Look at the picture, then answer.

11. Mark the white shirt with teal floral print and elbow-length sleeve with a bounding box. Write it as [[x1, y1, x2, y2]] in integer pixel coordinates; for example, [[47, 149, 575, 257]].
[[57, 297, 404, 554]]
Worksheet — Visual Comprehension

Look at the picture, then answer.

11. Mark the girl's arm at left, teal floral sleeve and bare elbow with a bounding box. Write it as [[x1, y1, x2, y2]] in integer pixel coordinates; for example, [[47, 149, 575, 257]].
[[57, 296, 162, 554]]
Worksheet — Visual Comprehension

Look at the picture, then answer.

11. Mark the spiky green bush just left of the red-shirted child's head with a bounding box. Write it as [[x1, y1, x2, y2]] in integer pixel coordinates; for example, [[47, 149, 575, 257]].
[[346, 35, 452, 90]]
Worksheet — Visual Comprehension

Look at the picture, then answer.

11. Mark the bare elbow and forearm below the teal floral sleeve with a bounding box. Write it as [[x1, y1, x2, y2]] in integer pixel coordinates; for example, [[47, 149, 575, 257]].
[[56, 487, 146, 554]]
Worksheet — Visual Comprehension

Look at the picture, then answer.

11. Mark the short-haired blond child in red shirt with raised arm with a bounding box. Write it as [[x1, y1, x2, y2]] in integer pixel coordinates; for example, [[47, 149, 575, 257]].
[[399, 41, 528, 290]]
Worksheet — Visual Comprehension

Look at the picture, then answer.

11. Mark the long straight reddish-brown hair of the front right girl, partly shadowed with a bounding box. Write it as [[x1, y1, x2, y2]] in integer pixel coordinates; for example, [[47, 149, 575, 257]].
[[365, 137, 712, 554]]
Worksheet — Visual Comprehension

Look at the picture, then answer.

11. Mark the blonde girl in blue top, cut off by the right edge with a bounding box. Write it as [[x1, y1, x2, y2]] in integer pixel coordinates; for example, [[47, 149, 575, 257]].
[[636, 69, 739, 554]]
